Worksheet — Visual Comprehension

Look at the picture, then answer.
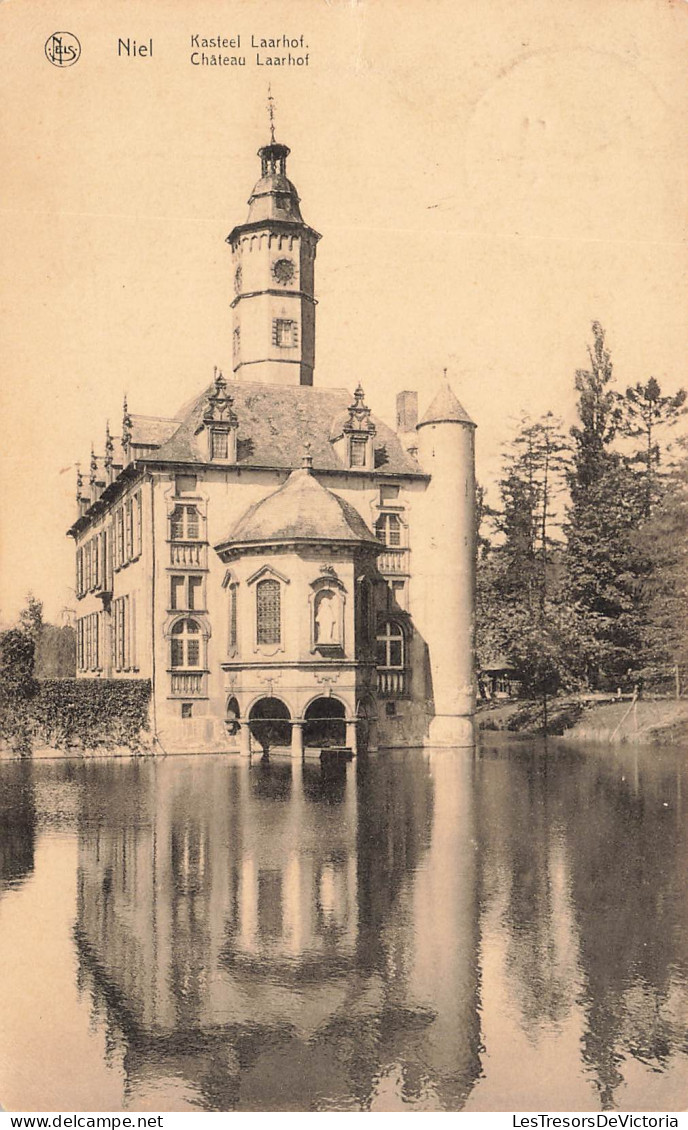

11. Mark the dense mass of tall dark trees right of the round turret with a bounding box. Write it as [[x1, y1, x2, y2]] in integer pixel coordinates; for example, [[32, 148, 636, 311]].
[[477, 322, 688, 695]]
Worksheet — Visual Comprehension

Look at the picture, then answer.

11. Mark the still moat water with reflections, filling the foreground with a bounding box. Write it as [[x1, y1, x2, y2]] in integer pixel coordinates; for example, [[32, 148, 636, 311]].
[[0, 741, 688, 1111]]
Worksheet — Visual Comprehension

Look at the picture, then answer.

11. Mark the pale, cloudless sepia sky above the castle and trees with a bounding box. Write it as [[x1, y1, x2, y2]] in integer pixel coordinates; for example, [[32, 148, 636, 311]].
[[0, 0, 688, 624]]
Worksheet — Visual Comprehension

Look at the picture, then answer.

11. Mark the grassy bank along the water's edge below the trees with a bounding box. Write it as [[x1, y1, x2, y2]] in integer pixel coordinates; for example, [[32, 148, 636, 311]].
[[478, 696, 688, 745]]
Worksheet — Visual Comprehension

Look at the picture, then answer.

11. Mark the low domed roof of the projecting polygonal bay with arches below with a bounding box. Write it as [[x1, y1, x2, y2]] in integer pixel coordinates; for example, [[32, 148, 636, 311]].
[[216, 468, 382, 549]]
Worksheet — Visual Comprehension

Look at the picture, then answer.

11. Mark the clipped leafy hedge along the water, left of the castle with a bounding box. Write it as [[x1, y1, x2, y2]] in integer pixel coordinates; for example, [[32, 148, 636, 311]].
[[0, 679, 151, 756]]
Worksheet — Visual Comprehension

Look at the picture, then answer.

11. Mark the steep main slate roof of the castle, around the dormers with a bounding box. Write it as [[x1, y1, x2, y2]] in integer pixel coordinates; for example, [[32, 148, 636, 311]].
[[150, 381, 423, 476]]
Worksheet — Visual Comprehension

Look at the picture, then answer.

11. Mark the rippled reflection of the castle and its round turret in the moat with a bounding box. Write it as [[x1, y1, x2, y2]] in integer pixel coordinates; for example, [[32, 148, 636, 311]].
[[76, 753, 480, 1110]]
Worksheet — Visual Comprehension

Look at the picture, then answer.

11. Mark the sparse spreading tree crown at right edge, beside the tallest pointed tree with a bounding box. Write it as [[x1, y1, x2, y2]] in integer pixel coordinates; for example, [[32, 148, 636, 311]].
[[619, 376, 686, 519]]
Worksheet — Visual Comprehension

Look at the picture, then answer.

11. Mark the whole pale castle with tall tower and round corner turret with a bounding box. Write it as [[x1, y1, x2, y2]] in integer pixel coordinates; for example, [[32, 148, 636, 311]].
[[69, 132, 474, 756]]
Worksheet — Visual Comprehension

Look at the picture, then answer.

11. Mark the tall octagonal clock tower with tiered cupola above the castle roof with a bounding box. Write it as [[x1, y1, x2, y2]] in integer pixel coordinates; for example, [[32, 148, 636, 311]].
[[227, 137, 320, 384]]
